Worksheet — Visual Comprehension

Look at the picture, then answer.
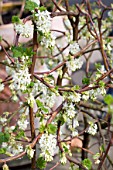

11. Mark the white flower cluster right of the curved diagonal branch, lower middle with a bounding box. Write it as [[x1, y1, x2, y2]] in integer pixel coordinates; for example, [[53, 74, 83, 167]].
[[63, 102, 77, 119]]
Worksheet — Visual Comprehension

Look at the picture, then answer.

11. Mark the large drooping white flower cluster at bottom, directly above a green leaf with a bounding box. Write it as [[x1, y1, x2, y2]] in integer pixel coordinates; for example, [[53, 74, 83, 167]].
[[39, 133, 57, 162]]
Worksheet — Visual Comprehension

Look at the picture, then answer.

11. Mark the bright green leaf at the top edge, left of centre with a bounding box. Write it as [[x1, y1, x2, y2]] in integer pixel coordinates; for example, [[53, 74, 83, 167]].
[[25, 1, 38, 11]]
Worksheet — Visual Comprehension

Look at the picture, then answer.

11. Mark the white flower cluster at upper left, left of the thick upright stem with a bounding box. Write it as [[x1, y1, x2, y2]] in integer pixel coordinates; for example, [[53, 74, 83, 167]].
[[14, 23, 32, 38]]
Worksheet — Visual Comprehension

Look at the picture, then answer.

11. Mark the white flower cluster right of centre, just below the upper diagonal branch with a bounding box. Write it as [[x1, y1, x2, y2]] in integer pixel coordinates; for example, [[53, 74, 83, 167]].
[[66, 57, 83, 71]]
